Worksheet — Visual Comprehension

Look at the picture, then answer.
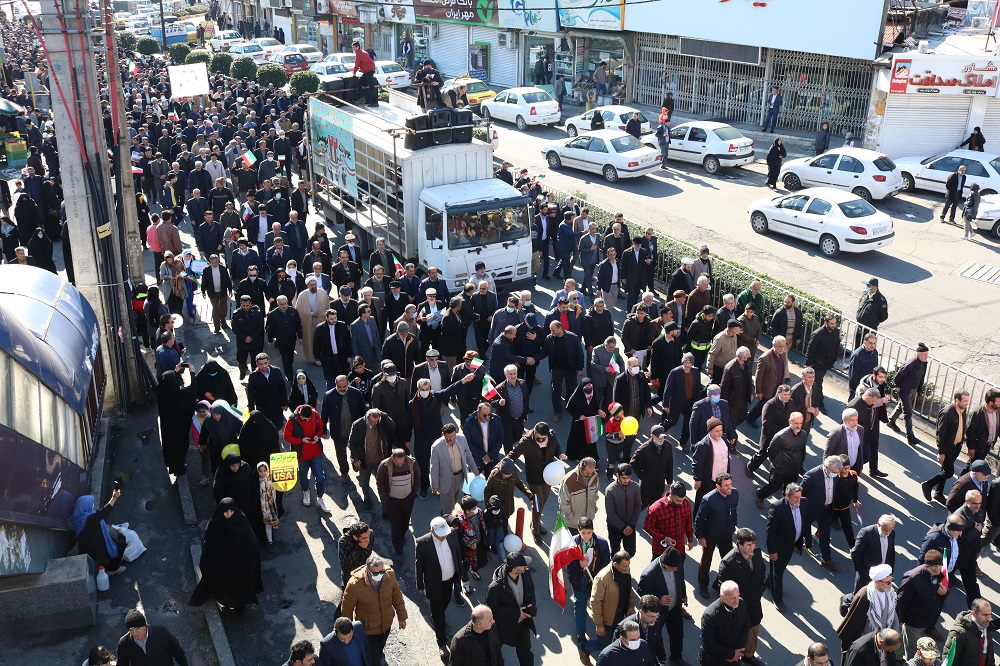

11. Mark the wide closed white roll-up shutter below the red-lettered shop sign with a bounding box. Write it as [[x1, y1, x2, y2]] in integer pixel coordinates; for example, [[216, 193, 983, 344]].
[[878, 95, 972, 157]]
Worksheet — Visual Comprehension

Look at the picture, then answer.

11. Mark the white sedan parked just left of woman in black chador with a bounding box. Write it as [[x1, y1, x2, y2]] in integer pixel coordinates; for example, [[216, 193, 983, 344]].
[[667, 121, 755, 174]]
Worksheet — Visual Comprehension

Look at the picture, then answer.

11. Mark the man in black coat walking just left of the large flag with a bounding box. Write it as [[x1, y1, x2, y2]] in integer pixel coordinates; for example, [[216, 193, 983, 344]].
[[486, 553, 538, 666]]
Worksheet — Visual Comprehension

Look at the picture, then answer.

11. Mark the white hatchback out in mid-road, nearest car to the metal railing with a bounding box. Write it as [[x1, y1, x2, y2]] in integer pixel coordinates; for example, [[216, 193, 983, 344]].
[[747, 187, 896, 257]]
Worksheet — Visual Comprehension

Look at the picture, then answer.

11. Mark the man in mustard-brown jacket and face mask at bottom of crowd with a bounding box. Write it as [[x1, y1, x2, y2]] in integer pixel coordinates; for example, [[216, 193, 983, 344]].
[[340, 553, 407, 665]]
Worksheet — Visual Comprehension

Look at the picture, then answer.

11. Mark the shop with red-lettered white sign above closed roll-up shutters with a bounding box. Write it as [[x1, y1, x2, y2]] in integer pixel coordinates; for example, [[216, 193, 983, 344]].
[[866, 53, 1000, 157]]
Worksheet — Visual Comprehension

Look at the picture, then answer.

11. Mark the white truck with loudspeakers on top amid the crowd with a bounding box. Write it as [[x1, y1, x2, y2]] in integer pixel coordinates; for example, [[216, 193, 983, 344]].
[[309, 94, 535, 300]]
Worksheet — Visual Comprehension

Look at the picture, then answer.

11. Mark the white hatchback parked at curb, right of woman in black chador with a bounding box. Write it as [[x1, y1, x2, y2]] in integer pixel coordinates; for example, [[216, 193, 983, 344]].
[[780, 146, 903, 201]]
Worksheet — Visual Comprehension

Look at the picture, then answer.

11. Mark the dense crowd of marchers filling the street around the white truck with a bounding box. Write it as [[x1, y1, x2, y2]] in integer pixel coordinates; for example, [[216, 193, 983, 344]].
[[0, 14, 1000, 666]]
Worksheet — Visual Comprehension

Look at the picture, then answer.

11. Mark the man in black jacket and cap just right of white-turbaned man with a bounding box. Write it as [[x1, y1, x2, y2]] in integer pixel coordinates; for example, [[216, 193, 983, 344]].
[[896, 550, 948, 659]]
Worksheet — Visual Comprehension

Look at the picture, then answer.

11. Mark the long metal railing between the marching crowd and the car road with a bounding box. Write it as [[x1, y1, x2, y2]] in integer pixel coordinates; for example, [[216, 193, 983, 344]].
[[545, 184, 1000, 423]]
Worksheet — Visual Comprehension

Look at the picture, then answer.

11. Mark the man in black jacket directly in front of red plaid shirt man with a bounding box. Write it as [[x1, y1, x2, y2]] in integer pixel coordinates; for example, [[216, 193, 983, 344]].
[[637, 546, 687, 663]]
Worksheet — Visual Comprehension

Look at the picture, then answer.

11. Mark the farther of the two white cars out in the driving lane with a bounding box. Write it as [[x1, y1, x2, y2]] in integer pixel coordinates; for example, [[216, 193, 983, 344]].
[[542, 129, 661, 183]]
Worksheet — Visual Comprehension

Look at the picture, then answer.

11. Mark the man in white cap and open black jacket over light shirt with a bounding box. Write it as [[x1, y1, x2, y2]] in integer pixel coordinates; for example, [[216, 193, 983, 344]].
[[414, 516, 464, 659]]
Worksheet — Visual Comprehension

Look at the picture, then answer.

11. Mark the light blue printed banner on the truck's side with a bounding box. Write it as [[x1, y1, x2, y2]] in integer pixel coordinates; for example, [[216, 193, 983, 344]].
[[309, 98, 358, 199]]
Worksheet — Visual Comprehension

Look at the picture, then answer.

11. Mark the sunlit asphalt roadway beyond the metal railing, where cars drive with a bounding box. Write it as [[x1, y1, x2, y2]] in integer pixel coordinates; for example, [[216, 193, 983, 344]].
[[497, 116, 1000, 381]]
